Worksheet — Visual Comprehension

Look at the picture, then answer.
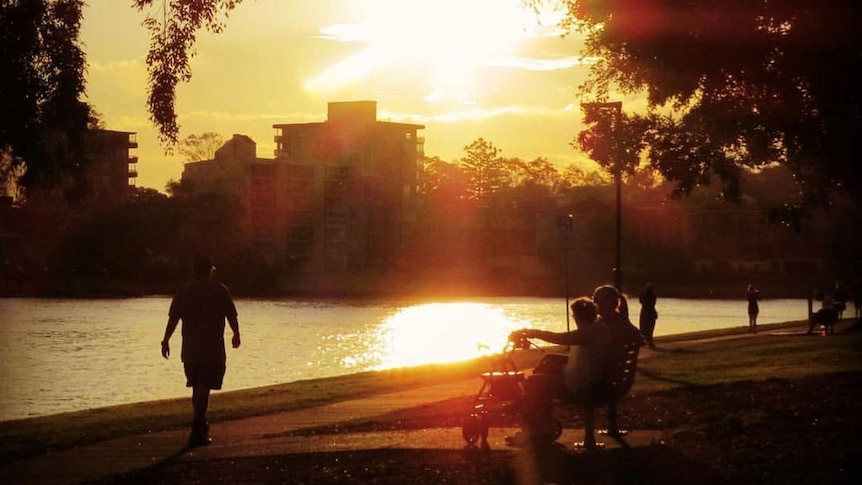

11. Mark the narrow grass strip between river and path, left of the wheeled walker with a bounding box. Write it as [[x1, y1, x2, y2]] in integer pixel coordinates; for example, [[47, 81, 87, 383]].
[[0, 360, 485, 462]]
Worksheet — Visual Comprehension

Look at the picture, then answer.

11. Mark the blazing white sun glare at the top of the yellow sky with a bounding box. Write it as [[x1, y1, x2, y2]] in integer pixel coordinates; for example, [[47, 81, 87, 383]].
[[306, 0, 552, 95]]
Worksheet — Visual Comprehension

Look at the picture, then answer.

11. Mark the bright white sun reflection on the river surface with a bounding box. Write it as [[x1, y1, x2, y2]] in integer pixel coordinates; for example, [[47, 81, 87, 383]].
[[367, 302, 528, 370]]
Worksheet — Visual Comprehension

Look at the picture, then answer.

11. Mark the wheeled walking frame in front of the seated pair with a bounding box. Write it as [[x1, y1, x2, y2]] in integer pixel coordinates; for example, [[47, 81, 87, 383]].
[[461, 338, 568, 449]]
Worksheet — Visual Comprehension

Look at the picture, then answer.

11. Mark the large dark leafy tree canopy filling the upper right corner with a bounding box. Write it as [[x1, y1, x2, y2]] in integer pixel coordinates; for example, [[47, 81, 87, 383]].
[[552, 0, 862, 216]]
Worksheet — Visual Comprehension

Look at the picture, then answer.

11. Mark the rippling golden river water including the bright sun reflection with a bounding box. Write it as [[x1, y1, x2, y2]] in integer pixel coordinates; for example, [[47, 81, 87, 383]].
[[0, 297, 808, 421]]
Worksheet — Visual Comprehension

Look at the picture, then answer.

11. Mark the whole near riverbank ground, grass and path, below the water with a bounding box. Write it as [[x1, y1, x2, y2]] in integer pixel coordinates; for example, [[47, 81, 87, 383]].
[[0, 320, 862, 484]]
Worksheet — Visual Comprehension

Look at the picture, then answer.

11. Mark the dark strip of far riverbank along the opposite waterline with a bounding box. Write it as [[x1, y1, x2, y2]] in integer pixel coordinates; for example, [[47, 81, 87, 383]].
[[0, 271, 836, 305]]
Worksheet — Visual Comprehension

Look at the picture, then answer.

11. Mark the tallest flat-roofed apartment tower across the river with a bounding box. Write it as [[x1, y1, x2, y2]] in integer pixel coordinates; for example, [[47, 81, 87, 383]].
[[273, 101, 424, 272]]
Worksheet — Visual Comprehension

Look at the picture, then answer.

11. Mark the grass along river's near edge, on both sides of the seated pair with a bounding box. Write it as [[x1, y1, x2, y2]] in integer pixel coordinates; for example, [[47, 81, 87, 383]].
[[0, 321, 862, 461]]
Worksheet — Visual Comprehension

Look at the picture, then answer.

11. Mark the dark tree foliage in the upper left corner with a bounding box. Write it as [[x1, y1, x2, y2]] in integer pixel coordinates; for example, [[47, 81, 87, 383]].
[[0, 0, 92, 196]]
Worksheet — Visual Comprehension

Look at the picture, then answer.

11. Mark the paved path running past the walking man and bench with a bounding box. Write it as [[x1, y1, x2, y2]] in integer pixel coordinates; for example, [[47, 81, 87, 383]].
[[0, 379, 661, 485]]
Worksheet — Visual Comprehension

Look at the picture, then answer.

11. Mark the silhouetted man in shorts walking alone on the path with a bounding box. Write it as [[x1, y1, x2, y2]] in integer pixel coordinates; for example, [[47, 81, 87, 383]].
[[162, 256, 240, 446]]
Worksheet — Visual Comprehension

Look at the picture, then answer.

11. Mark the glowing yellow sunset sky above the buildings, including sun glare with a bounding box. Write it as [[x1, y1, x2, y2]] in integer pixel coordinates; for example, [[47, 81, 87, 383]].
[[82, 0, 634, 190]]
